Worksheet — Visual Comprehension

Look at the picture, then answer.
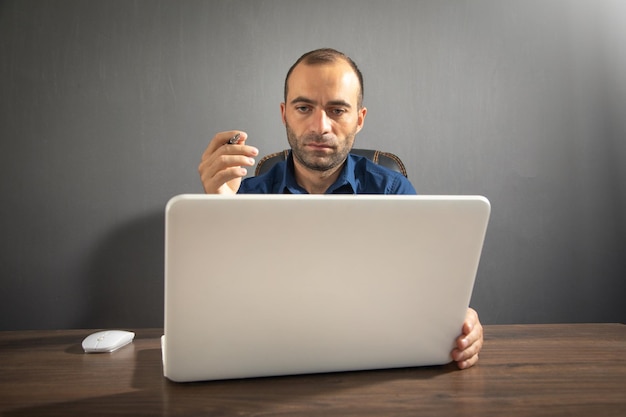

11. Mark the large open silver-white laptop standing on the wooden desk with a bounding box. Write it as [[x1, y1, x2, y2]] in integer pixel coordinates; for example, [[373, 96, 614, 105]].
[[162, 195, 490, 382]]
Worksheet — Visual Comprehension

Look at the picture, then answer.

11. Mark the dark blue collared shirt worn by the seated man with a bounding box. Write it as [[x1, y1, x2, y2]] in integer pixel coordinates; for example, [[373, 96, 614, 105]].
[[238, 153, 416, 194]]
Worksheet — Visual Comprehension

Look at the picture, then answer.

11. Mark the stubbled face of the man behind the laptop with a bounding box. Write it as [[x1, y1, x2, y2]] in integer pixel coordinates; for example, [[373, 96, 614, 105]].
[[280, 61, 367, 171]]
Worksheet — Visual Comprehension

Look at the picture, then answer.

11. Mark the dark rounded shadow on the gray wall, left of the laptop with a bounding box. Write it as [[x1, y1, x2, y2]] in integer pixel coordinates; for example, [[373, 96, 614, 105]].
[[78, 210, 165, 329]]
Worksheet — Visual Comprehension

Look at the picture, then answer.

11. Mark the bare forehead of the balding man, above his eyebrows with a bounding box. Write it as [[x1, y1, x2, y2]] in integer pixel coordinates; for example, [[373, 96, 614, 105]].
[[287, 61, 360, 103]]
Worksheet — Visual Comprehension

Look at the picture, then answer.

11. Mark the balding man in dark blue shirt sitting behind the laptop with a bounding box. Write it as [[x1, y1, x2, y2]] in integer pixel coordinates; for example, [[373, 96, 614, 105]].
[[198, 49, 483, 369]]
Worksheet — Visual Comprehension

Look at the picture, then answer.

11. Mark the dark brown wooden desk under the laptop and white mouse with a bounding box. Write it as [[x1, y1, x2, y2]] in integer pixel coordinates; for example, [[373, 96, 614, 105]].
[[0, 324, 626, 417]]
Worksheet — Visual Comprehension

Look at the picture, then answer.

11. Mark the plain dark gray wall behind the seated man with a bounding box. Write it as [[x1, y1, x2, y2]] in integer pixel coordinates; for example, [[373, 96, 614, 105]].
[[0, 0, 626, 330]]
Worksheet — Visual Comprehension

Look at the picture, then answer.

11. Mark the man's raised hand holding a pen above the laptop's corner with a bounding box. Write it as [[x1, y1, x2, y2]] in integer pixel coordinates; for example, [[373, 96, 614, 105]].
[[198, 131, 259, 194]]
